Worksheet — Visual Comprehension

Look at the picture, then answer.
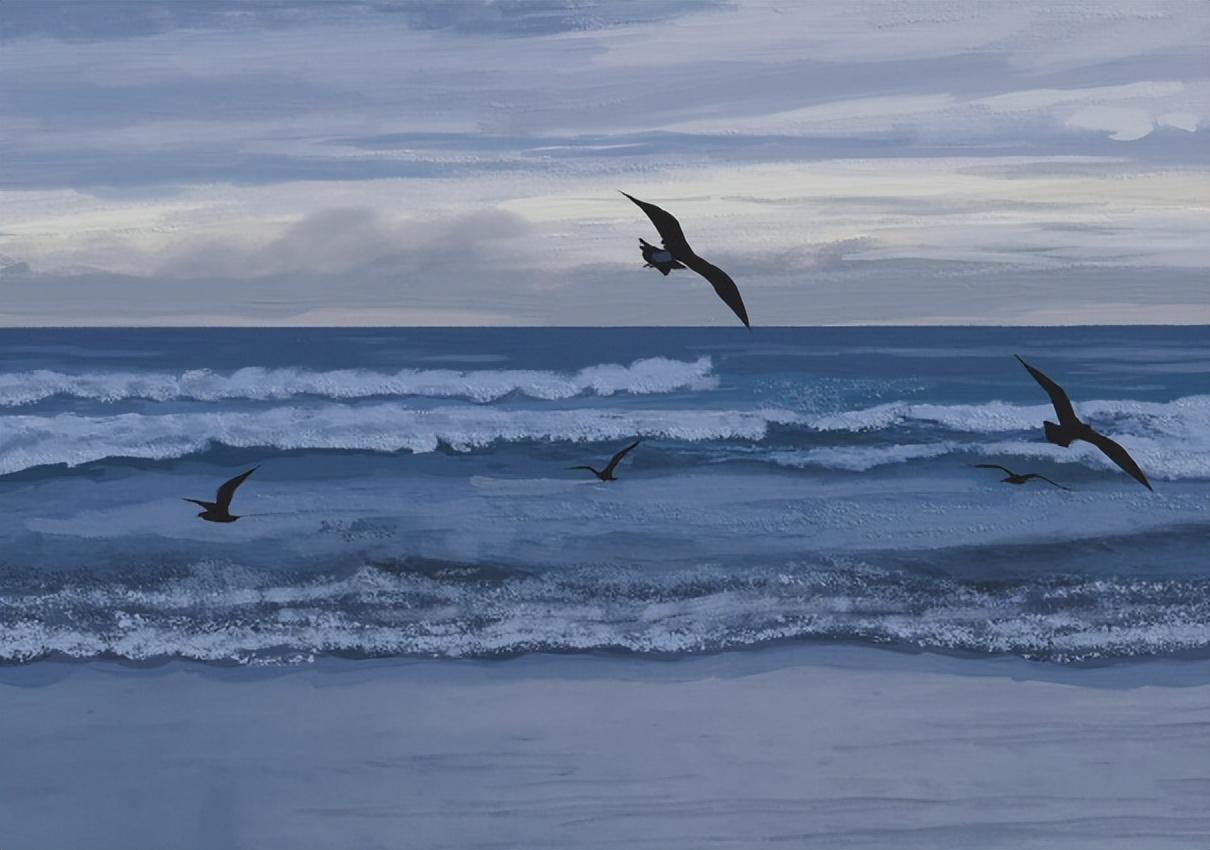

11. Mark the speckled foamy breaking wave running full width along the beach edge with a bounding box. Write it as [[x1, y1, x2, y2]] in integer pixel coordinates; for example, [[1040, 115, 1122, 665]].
[[0, 562, 1210, 664]]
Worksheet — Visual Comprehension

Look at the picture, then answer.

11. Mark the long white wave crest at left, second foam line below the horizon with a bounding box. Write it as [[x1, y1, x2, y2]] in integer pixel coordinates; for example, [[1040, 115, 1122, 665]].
[[0, 403, 797, 475]]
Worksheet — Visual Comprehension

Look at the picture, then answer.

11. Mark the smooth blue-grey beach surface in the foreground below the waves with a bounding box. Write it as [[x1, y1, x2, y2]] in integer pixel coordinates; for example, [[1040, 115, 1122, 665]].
[[0, 645, 1210, 850]]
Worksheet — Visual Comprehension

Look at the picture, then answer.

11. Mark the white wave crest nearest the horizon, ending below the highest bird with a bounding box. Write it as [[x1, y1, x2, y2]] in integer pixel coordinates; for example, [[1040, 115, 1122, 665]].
[[0, 357, 718, 407]]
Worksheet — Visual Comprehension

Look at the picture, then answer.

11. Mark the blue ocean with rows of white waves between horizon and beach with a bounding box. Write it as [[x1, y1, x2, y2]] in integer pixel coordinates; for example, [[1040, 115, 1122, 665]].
[[0, 326, 1210, 665]]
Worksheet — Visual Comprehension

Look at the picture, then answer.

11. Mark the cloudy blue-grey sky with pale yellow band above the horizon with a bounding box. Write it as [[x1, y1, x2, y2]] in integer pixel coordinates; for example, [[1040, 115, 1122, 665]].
[[0, 0, 1210, 326]]
